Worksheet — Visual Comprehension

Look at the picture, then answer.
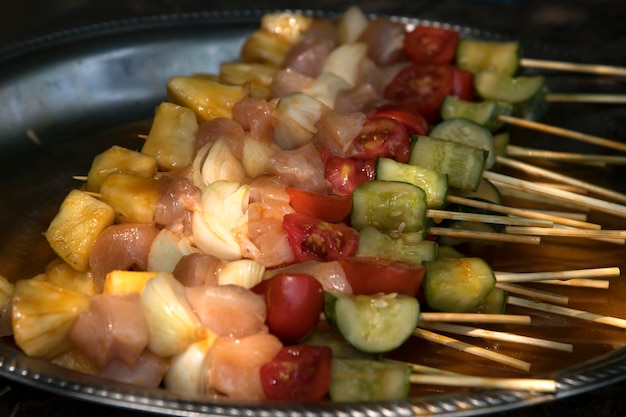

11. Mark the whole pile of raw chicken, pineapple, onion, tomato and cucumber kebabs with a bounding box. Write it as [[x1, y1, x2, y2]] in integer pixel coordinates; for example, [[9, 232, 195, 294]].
[[3, 4, 624, 401]]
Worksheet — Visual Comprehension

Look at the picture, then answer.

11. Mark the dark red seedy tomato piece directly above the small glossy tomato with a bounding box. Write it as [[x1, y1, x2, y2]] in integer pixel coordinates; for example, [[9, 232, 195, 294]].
[[348, 117, 411, 163]]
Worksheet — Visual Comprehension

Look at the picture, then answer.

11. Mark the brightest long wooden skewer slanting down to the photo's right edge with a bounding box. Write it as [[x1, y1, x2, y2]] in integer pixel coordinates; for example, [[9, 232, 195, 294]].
[[483, 171, 626, 219]]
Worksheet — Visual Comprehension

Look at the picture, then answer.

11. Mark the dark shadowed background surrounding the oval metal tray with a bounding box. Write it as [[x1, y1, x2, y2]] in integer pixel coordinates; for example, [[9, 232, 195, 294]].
[[0, 0, 626, 417]]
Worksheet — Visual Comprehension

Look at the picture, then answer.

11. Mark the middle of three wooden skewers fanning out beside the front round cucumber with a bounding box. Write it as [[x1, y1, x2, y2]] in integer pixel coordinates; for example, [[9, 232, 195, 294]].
[[420, 323, 574, 352]]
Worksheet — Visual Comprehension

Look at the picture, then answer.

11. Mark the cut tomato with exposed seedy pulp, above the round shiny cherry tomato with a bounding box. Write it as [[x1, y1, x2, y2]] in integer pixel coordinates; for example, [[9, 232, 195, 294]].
[[283, 213, 359, 262]]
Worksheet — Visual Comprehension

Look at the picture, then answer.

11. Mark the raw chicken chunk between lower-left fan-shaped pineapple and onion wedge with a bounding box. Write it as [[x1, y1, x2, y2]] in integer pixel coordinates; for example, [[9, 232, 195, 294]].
[[69, 293, 148, 368]]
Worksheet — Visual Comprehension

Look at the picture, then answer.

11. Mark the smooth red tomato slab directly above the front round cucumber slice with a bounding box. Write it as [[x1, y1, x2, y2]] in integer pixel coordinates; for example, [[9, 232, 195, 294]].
[[338, 256, 425, 297]]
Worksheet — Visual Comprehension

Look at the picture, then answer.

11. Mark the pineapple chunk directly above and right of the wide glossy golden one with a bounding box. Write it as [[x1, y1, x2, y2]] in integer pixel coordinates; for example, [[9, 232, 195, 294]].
[[220, 62, 278, 99]]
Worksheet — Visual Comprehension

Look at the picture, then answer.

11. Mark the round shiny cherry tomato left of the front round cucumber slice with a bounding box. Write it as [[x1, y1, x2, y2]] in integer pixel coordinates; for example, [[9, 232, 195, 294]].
[[252, 273, 324, 343]]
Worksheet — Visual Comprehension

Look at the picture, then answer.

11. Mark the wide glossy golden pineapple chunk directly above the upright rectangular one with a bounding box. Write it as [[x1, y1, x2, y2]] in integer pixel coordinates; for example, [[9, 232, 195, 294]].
[[167, 76, 250, 120]]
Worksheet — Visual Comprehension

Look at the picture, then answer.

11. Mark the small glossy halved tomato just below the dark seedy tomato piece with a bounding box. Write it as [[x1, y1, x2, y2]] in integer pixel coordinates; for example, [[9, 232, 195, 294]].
[[324, 156, 376, 196]]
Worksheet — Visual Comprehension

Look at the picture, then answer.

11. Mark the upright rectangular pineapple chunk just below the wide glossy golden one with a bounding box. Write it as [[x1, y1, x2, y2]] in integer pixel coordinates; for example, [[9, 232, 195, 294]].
[[141, 102, 198, 171]]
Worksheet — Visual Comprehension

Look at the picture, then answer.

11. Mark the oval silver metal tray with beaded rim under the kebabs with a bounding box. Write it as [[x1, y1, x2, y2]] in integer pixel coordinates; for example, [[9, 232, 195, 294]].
[[0, 10, 626, 417]]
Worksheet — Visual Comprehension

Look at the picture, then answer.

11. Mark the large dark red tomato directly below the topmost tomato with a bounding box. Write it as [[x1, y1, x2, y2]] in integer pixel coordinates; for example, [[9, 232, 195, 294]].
[[384, 64, 454, 123]]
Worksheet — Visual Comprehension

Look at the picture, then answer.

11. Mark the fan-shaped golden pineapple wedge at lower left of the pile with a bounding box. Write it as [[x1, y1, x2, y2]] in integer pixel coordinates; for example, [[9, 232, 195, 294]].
[[11, 279, 89, 359]]
